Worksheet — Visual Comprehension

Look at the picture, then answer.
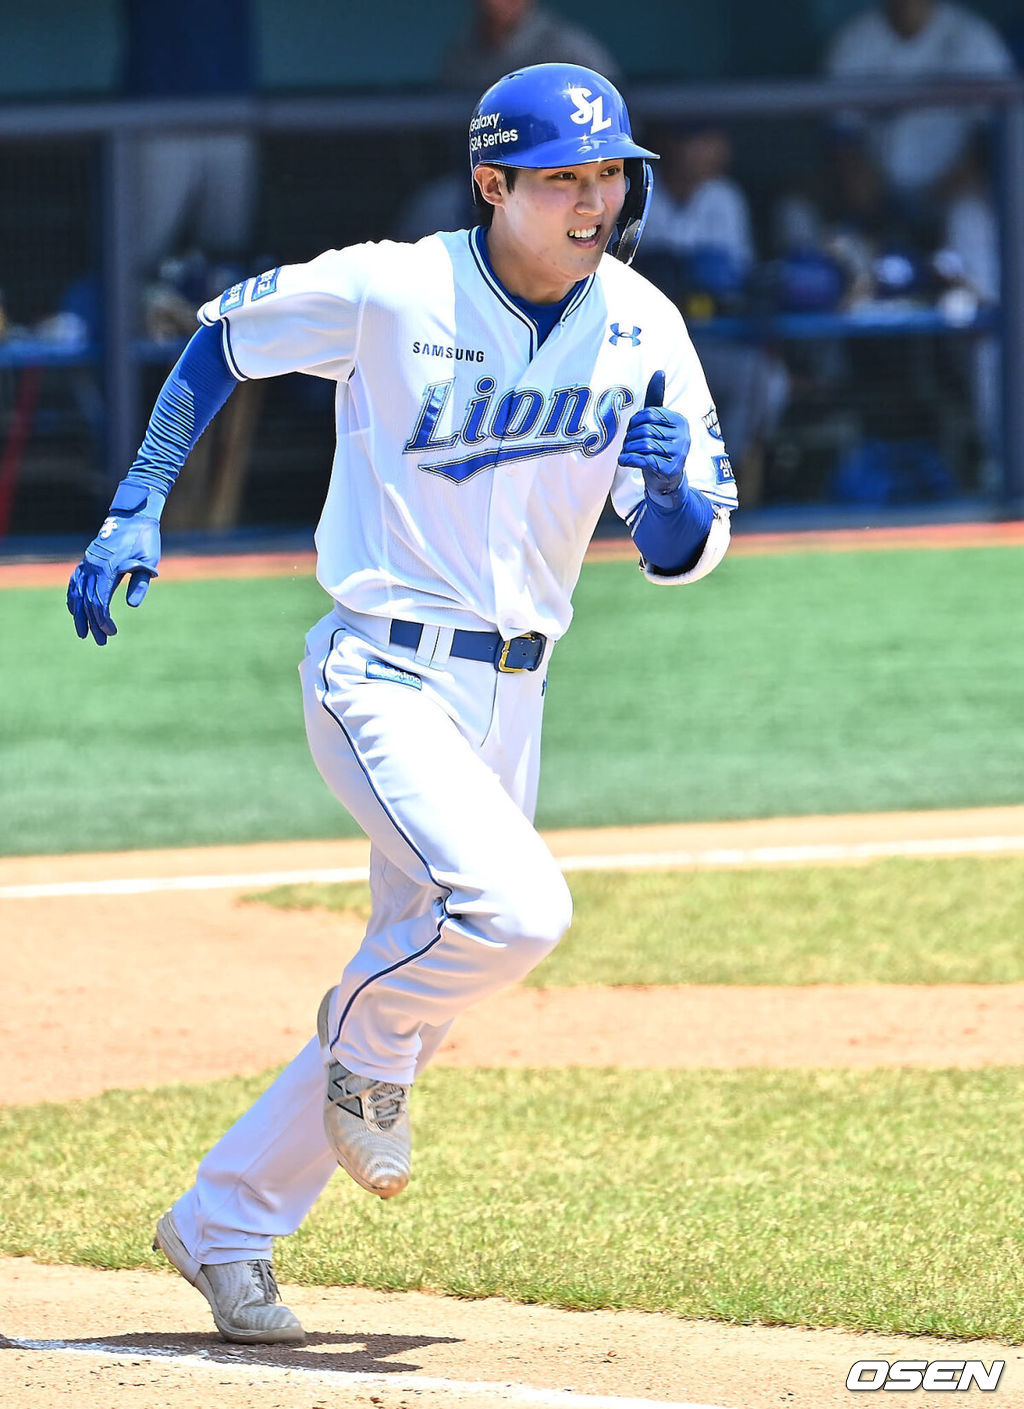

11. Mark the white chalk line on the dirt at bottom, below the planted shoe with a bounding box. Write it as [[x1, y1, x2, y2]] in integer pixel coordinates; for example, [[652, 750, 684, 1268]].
[[7, 1337, 721, 1409]]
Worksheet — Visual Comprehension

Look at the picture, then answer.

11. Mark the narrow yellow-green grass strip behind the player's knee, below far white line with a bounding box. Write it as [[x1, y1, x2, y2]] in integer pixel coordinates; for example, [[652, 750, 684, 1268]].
[[251, 857, 1024, 988]]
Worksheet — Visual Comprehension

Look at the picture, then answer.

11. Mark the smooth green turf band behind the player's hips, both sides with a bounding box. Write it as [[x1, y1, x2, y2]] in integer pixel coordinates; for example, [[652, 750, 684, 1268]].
[[0, 548, 1024, 854]]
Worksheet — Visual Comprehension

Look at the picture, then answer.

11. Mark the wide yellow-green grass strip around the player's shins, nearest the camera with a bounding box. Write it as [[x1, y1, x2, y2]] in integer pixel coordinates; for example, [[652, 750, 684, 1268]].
[[0, 1069, 1024, 1341]]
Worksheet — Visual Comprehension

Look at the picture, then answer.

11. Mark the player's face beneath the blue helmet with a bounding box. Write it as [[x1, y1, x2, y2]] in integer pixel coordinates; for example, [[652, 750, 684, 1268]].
[[482, 159, 625, 303]]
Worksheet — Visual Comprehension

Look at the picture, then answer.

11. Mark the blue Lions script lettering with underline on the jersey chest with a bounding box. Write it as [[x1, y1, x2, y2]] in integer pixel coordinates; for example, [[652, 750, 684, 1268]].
[[403, 376, 635, 485]]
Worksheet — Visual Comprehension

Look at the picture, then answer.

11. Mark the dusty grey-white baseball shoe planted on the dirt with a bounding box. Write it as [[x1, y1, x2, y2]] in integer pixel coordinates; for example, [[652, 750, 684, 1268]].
[[154, 1213, 306, 1346]]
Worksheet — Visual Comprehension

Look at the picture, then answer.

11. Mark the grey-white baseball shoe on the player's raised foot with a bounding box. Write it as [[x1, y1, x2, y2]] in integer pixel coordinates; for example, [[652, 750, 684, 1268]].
[[317, 988, 413, 1199]]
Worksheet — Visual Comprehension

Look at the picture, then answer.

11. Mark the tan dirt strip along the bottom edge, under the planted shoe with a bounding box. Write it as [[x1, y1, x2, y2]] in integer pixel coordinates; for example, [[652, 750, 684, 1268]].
[[0, 1260, 1024, 1409]]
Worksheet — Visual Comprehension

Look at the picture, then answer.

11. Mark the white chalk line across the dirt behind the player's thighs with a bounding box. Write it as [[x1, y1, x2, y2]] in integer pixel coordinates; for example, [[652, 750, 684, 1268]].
[[0, 836, 1024, 900]]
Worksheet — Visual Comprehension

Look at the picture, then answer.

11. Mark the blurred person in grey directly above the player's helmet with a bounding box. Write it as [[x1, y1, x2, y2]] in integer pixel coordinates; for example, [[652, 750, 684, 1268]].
[[432, 0, 618, 88]]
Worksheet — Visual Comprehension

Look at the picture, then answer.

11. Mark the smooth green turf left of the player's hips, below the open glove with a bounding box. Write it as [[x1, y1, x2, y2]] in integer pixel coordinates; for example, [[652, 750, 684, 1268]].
[[0, 566, 332, 854]]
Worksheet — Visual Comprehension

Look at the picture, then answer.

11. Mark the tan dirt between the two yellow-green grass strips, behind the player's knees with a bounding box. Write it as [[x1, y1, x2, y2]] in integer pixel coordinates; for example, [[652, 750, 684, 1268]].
[[0, 892, 1024, 1105]]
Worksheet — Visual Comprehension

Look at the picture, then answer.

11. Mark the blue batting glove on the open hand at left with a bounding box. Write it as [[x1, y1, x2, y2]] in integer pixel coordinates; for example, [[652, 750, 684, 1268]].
[[68, 483, 163, 645]]
